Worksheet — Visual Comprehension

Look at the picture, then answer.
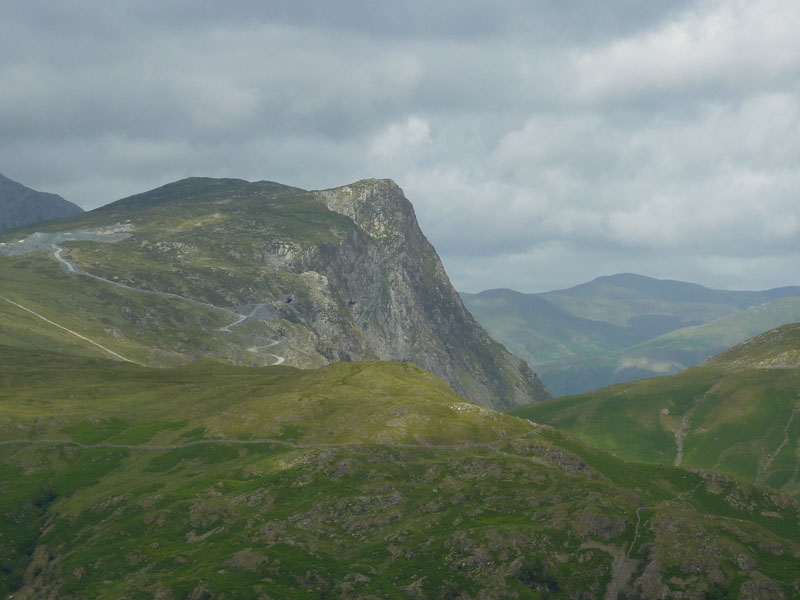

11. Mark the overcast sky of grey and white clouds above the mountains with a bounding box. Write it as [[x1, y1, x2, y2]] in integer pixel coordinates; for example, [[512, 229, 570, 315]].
[[0, 0, 800, 291]]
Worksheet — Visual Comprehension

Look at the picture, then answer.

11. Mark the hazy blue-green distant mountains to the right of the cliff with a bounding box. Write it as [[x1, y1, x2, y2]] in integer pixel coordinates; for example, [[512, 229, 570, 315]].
[[462, 274, 800, 396]]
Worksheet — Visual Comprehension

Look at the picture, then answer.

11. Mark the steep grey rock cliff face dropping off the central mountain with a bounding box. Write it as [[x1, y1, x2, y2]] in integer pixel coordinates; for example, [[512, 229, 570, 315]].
[[309, 179, 547, 408]]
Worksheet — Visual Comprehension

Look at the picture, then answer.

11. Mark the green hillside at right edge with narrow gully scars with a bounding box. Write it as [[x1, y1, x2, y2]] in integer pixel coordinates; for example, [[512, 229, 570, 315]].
[[512, 323, 800, 496]]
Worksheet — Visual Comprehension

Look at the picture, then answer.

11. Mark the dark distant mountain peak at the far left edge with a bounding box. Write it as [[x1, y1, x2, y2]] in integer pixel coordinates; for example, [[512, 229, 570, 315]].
[[0, 174, 83, 229]]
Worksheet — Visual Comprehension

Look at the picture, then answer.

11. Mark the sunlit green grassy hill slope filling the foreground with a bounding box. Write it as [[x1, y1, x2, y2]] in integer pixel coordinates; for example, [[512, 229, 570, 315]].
[[0, 347, 800, 600]]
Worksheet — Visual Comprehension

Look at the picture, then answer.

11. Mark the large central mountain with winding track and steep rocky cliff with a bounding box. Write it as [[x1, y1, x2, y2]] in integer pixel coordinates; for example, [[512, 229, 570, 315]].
[[0, 178, 548, 407]]
